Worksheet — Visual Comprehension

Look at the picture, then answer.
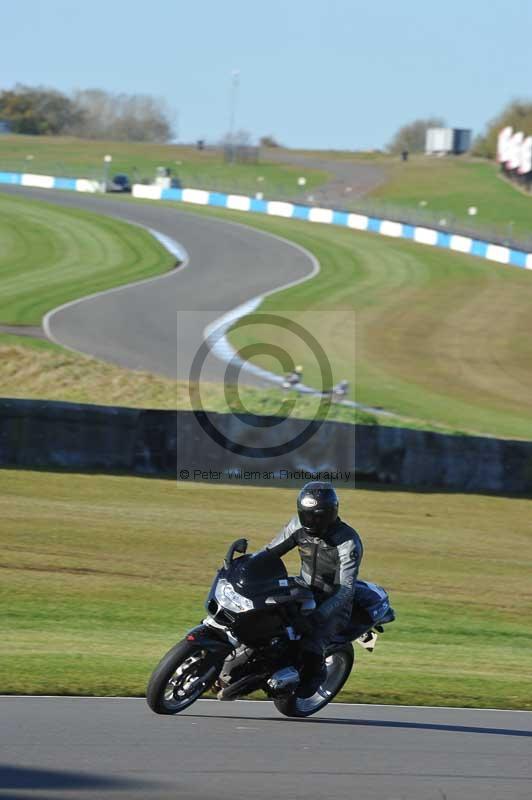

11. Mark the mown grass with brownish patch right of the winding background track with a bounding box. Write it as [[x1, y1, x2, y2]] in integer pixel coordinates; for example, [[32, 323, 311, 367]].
[[128, 201, 532, 439]]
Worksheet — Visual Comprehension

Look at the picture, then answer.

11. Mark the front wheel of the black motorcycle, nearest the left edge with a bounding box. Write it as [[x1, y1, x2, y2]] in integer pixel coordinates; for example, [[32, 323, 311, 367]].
[[146, 641, 223, 714]]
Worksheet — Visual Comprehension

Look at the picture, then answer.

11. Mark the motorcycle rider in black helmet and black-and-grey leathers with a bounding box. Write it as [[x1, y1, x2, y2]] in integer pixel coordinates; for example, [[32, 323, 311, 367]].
[[267, 481, 363, 696]]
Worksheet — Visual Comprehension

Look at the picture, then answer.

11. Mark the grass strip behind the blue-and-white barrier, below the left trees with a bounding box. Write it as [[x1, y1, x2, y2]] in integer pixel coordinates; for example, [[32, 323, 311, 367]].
[[0, 135, 329, 197]]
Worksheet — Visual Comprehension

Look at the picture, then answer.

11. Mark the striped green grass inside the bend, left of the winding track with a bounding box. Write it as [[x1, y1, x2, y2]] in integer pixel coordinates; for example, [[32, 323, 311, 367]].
[[0, 194, 175, 325]]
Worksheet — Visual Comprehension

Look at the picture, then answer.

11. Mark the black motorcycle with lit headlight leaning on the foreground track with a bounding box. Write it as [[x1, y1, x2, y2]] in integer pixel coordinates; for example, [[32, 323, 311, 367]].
[[146, 539, 395, 717]]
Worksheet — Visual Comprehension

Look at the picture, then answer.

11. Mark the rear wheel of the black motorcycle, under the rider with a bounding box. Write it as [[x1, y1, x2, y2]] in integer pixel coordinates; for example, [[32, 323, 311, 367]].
[[274, 643, 355, 717]]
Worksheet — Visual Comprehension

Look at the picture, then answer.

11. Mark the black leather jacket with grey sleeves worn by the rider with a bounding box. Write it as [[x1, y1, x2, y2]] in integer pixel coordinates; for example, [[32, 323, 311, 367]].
[[266, 517, 364, 621]]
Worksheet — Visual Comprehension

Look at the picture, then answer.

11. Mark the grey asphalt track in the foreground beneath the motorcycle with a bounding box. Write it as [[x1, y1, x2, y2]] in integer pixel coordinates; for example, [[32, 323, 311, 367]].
[[0, 697, 532, 800]]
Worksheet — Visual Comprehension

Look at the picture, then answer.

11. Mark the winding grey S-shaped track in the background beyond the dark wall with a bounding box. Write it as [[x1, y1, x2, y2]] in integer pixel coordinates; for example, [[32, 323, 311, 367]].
[[0, 187, 314, 383]]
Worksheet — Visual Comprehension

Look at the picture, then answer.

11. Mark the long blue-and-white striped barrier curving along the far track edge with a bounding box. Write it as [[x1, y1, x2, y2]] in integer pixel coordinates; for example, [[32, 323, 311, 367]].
[[0, 172, 532, 269]]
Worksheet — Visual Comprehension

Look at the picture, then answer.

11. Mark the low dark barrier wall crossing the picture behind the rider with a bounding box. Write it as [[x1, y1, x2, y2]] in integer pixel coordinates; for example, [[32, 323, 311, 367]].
[[0, 399, 532, 495]]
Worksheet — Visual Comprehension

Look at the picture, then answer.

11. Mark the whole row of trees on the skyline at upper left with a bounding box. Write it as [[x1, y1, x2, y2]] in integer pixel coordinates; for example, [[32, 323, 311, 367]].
[[0, 84, 174, 142]]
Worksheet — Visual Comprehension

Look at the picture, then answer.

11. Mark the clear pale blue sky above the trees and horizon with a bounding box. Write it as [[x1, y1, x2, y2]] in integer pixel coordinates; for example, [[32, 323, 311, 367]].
[[0, 0, 532, 149]]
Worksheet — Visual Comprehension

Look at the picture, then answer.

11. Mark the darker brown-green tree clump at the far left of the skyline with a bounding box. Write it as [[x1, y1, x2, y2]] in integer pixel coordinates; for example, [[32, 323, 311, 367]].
[[0, 84, 81, 135]]
